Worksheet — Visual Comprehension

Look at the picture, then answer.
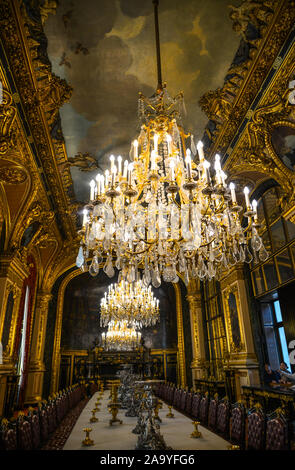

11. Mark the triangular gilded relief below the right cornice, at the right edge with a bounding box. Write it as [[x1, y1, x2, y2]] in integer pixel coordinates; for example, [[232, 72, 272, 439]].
[[225, 45, 295, 199]]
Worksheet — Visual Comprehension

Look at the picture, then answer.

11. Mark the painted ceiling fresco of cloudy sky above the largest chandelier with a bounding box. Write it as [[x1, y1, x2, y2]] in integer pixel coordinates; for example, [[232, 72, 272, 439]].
[[45, 0, 240, 201]]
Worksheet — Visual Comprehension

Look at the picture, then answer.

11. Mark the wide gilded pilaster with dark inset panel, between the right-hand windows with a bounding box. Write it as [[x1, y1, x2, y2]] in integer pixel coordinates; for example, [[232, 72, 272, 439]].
[[220, 267, 259, 398]]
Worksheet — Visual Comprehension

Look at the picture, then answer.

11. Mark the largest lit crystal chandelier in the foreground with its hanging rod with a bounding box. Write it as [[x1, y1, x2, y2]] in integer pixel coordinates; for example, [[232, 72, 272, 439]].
[[77, 1, 268, 287]]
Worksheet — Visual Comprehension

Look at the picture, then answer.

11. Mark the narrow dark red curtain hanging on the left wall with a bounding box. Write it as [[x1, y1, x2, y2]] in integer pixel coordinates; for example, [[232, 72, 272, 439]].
[[14, 256, 37, 408]]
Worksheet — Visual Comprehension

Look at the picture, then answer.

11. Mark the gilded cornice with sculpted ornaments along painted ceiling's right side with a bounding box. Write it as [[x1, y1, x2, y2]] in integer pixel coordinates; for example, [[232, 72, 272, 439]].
[[200, 0, 295, 157]]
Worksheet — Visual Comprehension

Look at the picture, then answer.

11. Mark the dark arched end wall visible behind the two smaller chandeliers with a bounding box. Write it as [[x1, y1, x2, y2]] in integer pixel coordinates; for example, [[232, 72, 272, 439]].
[[61, 270, 177, 351]]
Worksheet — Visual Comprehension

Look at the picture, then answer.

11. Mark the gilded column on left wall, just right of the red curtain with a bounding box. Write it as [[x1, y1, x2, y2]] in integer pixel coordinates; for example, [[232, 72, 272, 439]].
[[25, 291, 51, 403]]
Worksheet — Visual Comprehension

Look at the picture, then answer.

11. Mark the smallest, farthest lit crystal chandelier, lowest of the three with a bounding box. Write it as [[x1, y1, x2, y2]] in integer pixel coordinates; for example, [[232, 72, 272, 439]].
[[101, 321, 141, 351]]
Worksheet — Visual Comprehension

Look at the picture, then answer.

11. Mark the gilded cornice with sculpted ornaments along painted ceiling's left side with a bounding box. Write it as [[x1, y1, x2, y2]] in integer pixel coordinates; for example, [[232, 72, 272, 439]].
[[0, 0, 75, 238]]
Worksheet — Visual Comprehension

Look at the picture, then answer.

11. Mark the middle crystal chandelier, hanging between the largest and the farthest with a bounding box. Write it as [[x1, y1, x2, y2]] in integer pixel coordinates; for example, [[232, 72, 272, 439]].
[[100, 280, 160, 329]]
